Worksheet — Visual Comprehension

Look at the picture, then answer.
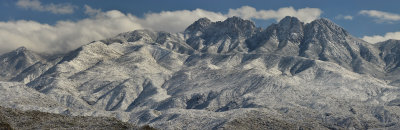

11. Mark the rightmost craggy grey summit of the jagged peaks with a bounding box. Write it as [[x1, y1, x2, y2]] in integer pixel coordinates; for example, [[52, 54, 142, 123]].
[[300, 19, 355, 62]]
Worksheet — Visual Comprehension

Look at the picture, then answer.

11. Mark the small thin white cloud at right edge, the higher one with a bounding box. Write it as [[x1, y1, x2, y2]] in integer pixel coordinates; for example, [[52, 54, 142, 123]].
[[359, 10, 400, 23]]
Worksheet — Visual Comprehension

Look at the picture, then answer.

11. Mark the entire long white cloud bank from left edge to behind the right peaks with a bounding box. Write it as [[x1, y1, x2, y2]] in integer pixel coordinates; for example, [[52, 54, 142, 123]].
[[0, 4, 322, 53]]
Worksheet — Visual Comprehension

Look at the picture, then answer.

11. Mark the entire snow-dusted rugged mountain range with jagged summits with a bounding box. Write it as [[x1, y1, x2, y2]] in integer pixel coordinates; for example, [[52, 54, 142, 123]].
[[0, 16, 400, 129]]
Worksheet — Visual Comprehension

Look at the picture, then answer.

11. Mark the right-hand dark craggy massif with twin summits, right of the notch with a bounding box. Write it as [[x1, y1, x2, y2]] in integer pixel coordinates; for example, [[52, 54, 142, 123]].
[[246, 17, 383, 75]]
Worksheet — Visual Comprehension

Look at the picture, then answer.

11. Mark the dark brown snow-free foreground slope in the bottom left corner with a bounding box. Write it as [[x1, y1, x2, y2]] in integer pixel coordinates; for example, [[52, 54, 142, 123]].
[[0, 107, 152, 130]]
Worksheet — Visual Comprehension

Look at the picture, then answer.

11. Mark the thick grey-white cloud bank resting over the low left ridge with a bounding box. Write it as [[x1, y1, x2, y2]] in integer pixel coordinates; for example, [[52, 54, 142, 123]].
[[0, 10, 142, 53]]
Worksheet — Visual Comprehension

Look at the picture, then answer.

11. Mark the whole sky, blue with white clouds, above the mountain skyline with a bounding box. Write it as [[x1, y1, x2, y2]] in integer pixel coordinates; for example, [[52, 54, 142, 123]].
[[0, 0, 400, 53]]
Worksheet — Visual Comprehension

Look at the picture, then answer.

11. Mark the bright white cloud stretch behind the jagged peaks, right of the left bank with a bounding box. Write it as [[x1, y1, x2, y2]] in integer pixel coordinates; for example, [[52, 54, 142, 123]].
[[137, 6, 322, 32]]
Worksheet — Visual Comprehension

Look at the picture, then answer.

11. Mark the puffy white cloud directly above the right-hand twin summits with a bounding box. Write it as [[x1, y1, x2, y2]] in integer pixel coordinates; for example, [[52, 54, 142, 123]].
[[228, 6, 322, 23]]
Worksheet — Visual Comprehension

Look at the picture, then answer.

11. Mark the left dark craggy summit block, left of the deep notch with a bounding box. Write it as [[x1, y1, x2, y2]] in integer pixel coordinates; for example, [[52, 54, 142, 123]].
[[185, 17, 261, 53]]
